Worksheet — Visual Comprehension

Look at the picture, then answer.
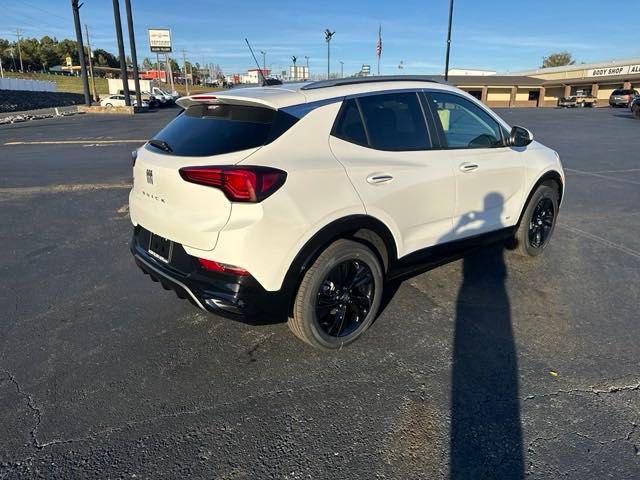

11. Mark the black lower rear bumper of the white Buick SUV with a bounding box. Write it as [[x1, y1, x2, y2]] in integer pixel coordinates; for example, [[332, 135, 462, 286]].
[[130, 226, 288, 323]]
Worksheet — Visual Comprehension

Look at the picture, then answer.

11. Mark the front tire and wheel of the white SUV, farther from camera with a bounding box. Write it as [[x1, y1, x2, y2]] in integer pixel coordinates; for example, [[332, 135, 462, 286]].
[[513, 183, 559, 257]]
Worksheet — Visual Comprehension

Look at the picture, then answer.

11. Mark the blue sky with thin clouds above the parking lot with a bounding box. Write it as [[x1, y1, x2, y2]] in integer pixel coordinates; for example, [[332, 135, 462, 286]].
[[0, 0, 640, 75]]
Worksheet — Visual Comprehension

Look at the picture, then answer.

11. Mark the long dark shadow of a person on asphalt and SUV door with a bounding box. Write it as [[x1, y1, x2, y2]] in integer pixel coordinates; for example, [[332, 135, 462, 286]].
[[449, 193, 524, 480]]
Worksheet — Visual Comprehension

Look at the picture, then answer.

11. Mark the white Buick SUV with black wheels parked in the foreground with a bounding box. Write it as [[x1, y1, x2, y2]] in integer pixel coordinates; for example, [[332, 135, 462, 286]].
[[130, 77, 564, 348]]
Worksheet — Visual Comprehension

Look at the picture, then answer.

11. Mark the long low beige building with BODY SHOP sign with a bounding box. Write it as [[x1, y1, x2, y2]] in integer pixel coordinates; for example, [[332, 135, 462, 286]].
[[449, 58, 640, 107]]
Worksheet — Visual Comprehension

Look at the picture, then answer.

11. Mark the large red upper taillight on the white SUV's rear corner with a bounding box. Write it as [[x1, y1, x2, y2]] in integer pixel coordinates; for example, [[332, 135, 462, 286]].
[[180, 167, 287, 203]]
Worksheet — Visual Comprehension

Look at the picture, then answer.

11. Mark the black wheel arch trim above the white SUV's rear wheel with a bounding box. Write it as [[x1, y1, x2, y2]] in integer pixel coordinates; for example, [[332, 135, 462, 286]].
[[283, 215, 398, 314]]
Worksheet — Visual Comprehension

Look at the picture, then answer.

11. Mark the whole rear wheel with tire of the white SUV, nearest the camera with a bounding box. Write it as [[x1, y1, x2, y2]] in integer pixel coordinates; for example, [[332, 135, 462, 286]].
[[289, 239, 384, 350]]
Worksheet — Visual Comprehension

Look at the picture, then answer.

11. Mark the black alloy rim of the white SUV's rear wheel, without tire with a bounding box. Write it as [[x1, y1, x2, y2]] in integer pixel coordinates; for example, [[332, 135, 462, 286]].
[[315, 259, 375, 337]]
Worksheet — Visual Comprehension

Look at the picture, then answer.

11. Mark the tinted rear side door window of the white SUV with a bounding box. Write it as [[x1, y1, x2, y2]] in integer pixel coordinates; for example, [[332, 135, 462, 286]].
[[358, 92, 431, 150]]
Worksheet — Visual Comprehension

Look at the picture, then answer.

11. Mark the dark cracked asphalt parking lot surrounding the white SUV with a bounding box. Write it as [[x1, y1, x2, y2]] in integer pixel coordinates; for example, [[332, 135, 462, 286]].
[[0, 108, 640, 479]]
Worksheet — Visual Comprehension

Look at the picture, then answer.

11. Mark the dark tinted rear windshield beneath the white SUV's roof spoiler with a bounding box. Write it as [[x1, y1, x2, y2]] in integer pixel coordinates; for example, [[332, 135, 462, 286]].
[[150, 104, 298, 157]]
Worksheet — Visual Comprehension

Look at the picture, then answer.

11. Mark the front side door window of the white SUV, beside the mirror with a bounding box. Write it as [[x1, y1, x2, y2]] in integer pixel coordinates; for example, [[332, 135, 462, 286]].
[[429, 92, 504, 148]]
